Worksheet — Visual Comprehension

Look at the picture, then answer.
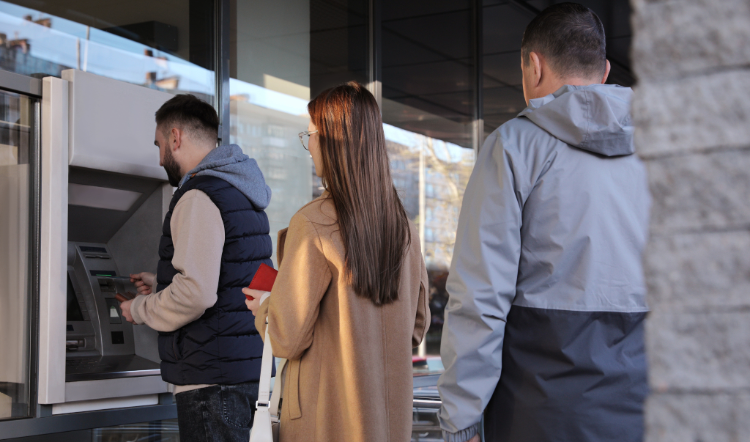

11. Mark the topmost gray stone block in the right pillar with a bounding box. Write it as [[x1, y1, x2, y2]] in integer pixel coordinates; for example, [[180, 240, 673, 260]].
[[632, 0, 750, 81]]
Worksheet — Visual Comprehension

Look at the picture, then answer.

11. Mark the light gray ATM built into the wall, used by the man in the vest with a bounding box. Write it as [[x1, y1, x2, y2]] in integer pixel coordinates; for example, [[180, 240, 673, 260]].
[[38, 70, 178, 415]]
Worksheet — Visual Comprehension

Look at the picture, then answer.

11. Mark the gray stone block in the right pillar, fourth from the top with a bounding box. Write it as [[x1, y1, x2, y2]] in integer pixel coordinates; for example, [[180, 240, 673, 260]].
[[644, 230, 750, 311]]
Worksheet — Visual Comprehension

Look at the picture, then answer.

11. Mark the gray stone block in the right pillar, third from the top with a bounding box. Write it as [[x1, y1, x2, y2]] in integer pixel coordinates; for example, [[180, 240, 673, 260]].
[[646, 148, 750, 235]]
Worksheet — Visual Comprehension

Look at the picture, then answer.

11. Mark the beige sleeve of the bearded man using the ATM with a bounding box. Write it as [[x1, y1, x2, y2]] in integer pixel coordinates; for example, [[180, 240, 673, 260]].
[[131, 189, 224, 332]]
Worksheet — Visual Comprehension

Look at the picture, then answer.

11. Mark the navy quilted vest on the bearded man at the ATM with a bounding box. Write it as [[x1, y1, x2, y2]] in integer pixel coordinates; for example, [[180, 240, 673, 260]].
[[156, 176, 273, 385]]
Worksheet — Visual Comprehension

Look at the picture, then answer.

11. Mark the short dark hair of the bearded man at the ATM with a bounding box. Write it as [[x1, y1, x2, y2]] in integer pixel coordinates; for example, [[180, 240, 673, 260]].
[[156, 94, 219, 141]]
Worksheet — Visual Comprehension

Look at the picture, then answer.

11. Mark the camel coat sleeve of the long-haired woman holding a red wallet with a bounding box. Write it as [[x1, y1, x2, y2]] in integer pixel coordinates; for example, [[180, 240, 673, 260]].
[[255, 213, 331, 360]]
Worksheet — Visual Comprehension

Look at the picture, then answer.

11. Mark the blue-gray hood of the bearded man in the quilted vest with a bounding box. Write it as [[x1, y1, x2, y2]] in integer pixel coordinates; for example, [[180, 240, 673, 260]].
[[180, 144, 271, 209]]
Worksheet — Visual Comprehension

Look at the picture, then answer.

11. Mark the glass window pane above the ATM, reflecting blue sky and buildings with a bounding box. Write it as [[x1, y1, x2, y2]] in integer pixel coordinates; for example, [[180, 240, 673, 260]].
[[0, 0, 215, 104]]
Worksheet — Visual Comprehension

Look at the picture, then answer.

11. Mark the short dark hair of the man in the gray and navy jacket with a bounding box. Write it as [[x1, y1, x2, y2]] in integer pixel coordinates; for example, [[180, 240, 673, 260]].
[[521, 3, 607, 78]]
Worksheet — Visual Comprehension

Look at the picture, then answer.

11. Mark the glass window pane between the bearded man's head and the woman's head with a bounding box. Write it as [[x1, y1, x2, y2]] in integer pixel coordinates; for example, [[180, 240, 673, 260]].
[[229, 0, 368, 259]]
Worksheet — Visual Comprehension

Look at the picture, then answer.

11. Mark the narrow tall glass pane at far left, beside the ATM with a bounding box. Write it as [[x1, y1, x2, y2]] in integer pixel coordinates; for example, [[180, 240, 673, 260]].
[[0, 88, 36, 420]]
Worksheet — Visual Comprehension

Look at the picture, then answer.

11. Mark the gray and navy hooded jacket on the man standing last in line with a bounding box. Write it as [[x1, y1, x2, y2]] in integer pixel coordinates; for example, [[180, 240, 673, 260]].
[[438, 84, 650, 442]]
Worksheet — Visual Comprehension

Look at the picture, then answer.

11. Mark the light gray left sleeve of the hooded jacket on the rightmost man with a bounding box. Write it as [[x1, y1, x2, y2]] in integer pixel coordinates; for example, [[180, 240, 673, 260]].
[[438, 131, 523, 442]]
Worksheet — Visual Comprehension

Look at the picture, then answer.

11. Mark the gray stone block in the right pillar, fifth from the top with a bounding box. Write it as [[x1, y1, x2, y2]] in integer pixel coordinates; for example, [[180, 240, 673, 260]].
[[646, 310, 750, 393]]
